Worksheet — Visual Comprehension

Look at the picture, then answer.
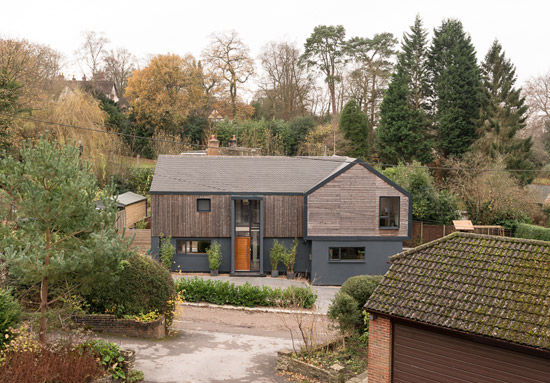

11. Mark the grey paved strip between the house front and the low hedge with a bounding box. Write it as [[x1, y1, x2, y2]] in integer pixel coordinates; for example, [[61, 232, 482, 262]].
[[172, 273, 340, 314]]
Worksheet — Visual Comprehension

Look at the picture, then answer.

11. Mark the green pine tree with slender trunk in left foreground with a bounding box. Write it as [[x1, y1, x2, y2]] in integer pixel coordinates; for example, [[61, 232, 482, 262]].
[[0, 138, 133, 342]]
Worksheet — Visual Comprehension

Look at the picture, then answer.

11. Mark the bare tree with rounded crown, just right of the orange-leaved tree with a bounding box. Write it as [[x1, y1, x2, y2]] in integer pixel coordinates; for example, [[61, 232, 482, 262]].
[[203, 31, 254, 117]]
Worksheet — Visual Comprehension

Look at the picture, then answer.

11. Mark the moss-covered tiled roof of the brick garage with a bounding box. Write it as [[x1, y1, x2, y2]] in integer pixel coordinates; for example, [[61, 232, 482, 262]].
[[365, 233, 550, 350]]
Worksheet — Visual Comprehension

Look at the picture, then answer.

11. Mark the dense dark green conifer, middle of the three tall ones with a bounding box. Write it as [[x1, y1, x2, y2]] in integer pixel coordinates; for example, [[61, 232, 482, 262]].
[[428, 19, 480, 157]]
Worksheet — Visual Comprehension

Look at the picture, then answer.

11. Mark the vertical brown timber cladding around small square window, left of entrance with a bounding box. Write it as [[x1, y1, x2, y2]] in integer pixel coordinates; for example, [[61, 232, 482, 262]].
[[151, 194, 231, 238]]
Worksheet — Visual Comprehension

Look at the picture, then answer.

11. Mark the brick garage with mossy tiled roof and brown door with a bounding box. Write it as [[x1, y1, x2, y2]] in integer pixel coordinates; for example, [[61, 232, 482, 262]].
[[365, 232, 550, 383]]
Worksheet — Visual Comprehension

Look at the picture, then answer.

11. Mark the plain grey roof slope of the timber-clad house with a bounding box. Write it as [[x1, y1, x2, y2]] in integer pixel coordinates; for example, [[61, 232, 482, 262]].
[[150, 155, 355, 194]]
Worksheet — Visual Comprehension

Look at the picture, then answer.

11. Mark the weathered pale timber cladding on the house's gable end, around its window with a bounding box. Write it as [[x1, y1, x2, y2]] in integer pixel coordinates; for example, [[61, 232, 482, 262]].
[[307, 164, 409, 237]]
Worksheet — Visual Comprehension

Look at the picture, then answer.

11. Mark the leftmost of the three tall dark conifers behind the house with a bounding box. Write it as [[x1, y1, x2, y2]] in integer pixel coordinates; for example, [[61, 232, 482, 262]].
[[375, 16, 433, 164]]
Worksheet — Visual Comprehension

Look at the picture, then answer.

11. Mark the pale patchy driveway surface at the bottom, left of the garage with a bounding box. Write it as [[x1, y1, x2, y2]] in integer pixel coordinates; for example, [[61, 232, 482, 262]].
[[109, 322, 298, 383]]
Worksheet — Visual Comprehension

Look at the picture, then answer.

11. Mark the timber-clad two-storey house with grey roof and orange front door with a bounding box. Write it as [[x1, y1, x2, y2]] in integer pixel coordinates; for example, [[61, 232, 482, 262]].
[[150, 149, 412, 285]]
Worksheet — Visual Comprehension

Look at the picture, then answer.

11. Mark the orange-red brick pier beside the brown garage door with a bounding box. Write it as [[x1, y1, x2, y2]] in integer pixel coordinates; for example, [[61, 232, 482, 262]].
[[368, 316, 392, 383]]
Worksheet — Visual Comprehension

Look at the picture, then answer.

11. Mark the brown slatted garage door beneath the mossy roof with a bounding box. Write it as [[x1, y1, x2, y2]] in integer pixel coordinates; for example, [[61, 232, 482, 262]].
[[393, 323, 550, 383]]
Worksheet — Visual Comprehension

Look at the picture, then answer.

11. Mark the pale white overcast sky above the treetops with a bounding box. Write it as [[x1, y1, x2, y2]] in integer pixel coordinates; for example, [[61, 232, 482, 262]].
[[0, 0, 550, 84]]
